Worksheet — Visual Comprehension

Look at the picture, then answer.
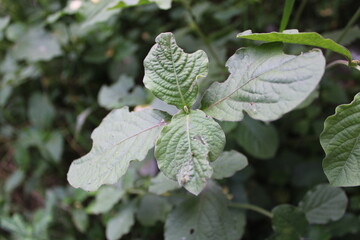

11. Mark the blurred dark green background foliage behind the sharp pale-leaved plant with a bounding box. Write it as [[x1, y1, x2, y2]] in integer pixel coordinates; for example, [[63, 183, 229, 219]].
[[0, 0, 360, 240]]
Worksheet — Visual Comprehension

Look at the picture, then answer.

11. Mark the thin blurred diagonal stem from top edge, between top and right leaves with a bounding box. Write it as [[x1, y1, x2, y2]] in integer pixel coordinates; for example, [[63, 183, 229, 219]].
[[181, 0, 227, 71]]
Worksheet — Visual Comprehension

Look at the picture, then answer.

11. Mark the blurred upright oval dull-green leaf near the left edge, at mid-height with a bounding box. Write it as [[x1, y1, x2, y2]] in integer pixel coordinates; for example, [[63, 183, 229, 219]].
[[28, 93, 55, 128]]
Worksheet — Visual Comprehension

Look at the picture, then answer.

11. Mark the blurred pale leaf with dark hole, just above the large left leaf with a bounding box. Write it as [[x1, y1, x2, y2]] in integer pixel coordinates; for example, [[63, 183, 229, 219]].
[[98, 75, 146, 110]]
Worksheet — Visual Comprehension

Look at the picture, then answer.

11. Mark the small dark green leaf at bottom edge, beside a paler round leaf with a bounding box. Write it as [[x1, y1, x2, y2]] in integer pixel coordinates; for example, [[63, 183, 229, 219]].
[[272, 204, 308, 240]]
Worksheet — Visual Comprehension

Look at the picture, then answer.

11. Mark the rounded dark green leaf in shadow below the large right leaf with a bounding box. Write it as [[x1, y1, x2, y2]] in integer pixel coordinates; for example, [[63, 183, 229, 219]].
[[235, 116, 279, 159]]
